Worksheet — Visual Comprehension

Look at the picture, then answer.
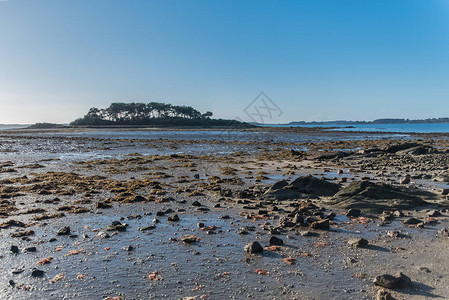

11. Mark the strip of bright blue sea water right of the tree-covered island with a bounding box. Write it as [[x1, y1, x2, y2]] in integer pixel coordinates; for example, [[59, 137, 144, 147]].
[[274, 123, 449, 133]]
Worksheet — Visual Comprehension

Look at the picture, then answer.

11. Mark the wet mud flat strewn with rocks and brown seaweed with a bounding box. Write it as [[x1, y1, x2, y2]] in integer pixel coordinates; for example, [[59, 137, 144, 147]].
[[0, 130, 449, 299]]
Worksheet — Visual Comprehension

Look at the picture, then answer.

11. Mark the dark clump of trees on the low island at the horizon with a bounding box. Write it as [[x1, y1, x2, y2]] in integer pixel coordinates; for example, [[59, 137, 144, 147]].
[[71, 102, 253, 127]]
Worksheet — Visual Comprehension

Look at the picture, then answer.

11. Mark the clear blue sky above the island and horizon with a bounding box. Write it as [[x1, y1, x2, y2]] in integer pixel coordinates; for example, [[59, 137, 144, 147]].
[[0, 0, 449, 123]]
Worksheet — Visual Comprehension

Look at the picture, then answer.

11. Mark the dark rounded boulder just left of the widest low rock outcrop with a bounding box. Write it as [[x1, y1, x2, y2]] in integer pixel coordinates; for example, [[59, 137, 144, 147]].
[[286, 175, 340, 196]]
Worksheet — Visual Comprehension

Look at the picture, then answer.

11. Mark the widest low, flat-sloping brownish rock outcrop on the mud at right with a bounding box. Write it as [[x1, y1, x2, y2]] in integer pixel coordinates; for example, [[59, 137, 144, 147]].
[[330, 181, 427, 213]]
